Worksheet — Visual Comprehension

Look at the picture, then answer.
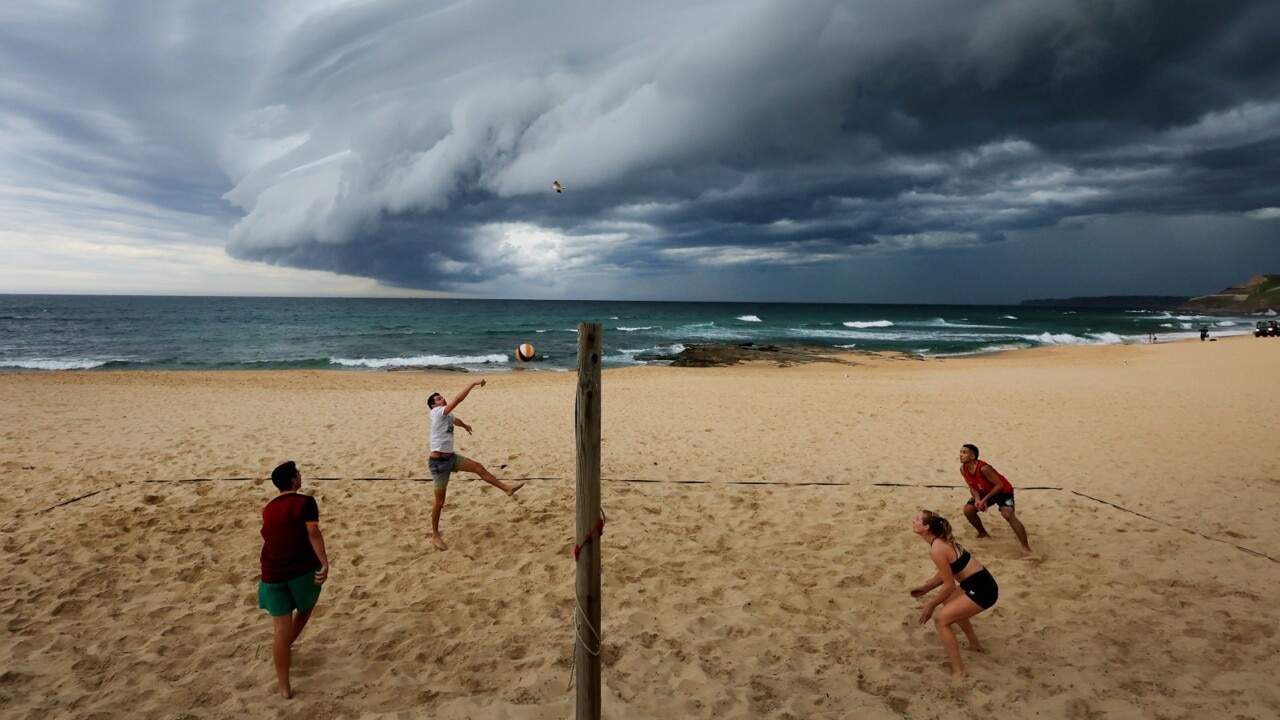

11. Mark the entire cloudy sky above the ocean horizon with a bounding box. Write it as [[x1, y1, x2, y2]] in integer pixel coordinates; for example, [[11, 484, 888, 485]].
[[0, 0, 1280, 304]]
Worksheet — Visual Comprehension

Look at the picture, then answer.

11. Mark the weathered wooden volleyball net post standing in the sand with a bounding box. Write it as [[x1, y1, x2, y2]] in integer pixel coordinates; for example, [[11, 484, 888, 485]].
[[573, 323, 604, 720]]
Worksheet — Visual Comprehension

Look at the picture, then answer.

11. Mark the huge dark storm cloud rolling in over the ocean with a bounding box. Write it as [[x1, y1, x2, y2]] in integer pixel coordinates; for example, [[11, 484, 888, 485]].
[[212, 1, 1280, 288]]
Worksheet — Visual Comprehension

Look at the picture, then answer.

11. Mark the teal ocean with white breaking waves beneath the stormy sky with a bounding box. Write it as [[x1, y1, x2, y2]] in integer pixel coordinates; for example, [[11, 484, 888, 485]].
[[0, 295, 1257, 373]]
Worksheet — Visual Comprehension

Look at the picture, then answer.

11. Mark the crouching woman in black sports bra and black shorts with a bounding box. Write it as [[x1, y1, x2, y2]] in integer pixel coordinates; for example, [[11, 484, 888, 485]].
[[911, 510, 1000, 678]]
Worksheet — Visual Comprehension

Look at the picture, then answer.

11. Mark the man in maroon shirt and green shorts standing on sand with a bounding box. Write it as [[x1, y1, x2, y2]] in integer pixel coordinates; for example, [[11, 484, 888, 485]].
[[257, 461, 329, 698]]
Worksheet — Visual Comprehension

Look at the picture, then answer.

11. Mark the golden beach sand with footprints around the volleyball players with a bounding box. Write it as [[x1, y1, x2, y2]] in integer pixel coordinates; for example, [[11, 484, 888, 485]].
[[0, 336, 1280, 719]]
